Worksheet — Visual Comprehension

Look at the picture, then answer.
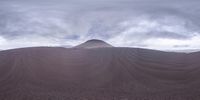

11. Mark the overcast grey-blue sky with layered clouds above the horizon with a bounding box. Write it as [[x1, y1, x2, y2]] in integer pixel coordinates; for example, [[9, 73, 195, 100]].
[[0, 0, 200, 50]]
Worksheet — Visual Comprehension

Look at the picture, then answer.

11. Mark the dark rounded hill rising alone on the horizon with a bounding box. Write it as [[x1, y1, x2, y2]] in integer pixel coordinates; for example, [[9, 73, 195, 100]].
[[75, 39, 113, 48]]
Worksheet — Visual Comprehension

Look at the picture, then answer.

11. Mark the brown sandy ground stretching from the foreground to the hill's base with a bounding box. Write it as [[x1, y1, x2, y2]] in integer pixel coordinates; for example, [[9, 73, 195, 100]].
[[0, 41, 200, 100]]
